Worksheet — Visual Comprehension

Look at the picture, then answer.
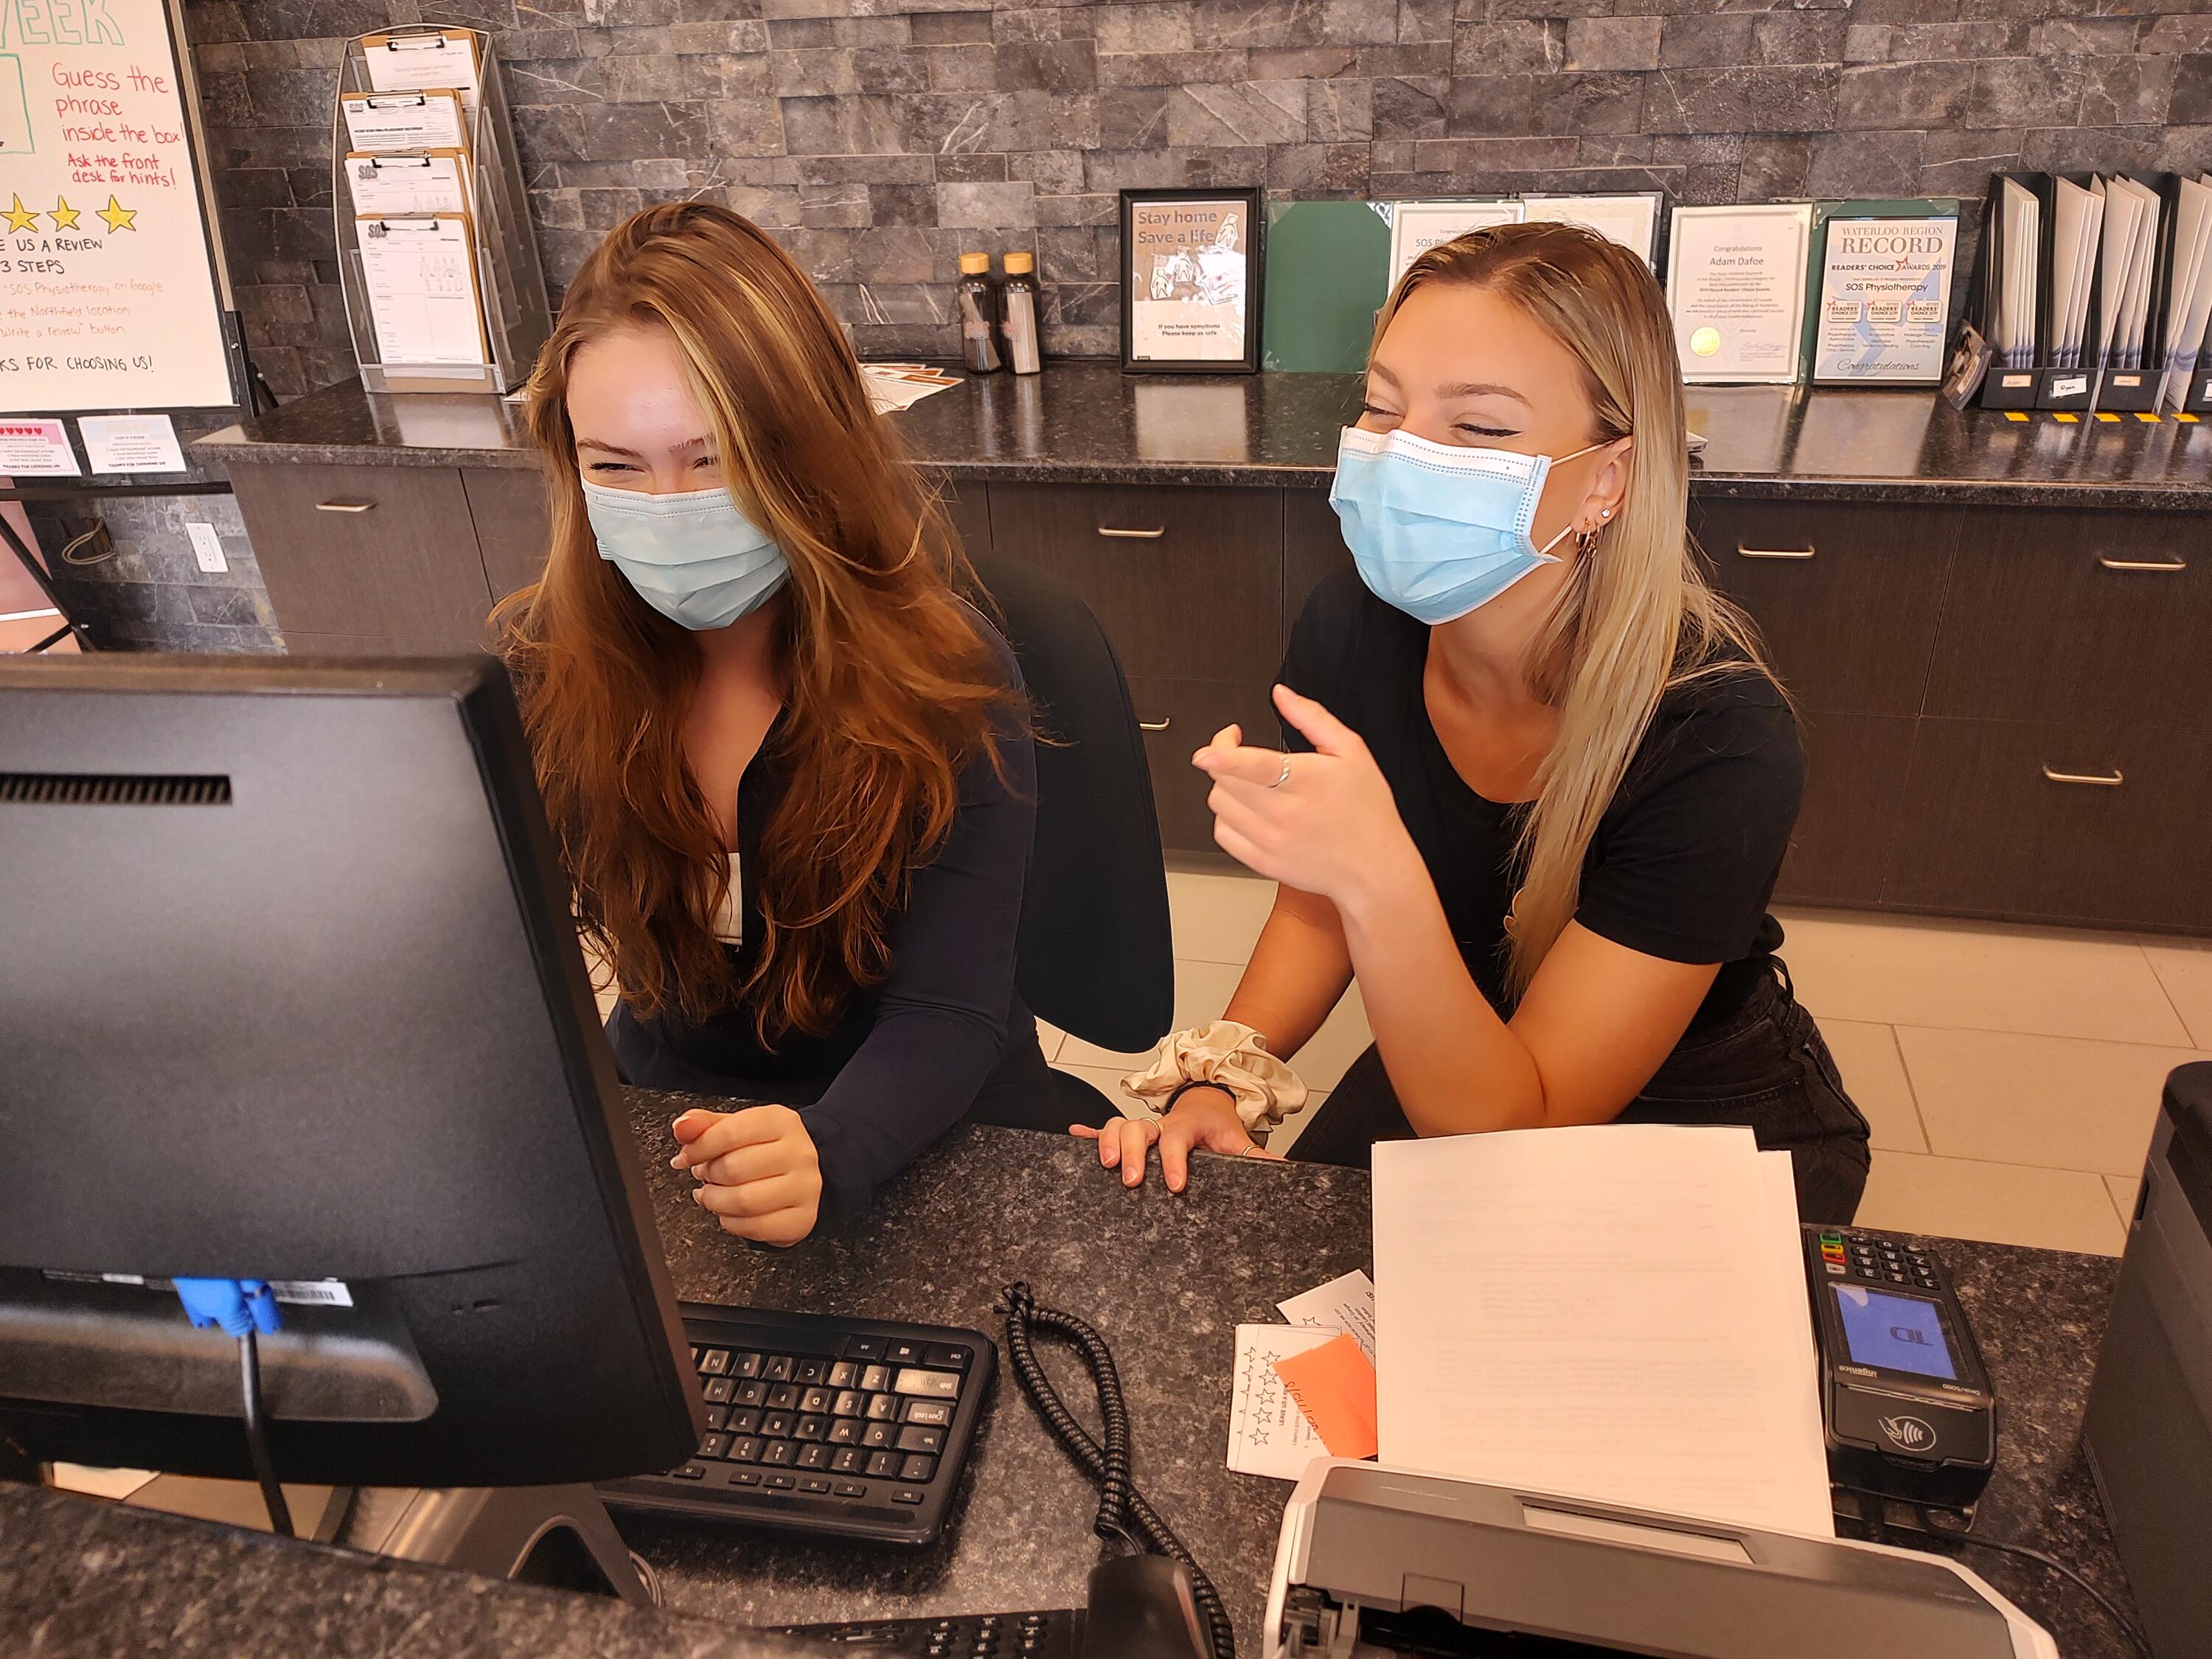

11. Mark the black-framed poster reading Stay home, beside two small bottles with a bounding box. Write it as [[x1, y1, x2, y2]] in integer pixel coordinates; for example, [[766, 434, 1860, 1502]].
[[1121, 190, 1263, 374]]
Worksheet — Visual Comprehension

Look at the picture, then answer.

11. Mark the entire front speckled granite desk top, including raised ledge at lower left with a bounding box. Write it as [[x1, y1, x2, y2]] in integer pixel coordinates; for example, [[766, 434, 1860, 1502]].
[[0, 1091, 2128, 1659]]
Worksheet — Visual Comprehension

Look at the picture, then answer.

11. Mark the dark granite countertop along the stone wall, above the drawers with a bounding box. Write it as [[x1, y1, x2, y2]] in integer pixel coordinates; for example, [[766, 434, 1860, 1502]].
[[192, 358, 2212, 509]]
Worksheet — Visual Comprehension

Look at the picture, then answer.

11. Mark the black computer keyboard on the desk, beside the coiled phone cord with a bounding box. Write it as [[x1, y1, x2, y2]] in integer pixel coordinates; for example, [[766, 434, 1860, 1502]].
[[599, 1303, 995, 1557]]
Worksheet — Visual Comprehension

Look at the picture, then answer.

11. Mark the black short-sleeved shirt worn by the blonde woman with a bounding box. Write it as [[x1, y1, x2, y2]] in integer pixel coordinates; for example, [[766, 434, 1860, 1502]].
[[1283, 571, 1805, 1031]]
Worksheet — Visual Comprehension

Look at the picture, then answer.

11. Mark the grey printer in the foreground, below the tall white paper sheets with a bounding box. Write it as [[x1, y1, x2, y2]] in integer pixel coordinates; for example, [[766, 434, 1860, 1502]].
[[1263, 1460, 2059, 1659]]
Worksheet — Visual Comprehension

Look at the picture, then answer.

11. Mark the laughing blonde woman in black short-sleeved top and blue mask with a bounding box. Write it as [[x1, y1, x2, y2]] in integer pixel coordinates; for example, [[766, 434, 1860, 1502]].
[[1075, 223, 1869, 1221]]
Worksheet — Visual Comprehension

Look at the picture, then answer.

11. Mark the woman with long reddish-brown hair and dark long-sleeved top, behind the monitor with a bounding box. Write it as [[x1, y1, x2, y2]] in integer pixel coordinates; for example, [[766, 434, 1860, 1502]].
[[504, 204, 1113, 1243]]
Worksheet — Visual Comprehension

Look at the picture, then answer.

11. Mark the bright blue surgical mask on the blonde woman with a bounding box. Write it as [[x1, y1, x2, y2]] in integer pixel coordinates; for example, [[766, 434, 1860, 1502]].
[[1329, 427, 1610, 628]]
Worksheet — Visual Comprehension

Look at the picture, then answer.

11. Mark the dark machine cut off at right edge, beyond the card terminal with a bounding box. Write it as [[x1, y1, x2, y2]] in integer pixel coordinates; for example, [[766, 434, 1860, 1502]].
[[2081, 1062, 2212, 1659]]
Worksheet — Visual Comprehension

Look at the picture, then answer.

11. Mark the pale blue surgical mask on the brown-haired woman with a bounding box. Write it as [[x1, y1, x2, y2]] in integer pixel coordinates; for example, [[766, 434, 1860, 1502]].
[[584, 478, 790, 630]]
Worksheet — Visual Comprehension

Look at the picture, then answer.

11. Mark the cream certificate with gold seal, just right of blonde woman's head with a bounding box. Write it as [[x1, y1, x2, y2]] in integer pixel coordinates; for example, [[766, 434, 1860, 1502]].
[[1666, 201, 1812, 385]]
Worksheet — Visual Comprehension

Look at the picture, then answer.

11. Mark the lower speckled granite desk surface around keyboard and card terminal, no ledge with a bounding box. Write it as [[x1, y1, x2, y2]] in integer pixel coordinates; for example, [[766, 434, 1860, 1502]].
[[624, 1093, 2128, 1659]]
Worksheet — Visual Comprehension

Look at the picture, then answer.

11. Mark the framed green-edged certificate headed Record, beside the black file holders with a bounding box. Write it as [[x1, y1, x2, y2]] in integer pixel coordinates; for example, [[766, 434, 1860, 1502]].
[[1812, 219, 1958, 385]]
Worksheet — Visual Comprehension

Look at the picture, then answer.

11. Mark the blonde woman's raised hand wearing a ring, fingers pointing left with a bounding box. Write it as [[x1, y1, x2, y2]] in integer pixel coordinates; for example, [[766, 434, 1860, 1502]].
[[1190, 686, 1427, 925]]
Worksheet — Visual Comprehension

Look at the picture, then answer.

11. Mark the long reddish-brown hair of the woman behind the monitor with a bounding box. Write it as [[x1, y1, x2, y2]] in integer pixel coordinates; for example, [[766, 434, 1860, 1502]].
[[500, 204, 1013, 1042]]
